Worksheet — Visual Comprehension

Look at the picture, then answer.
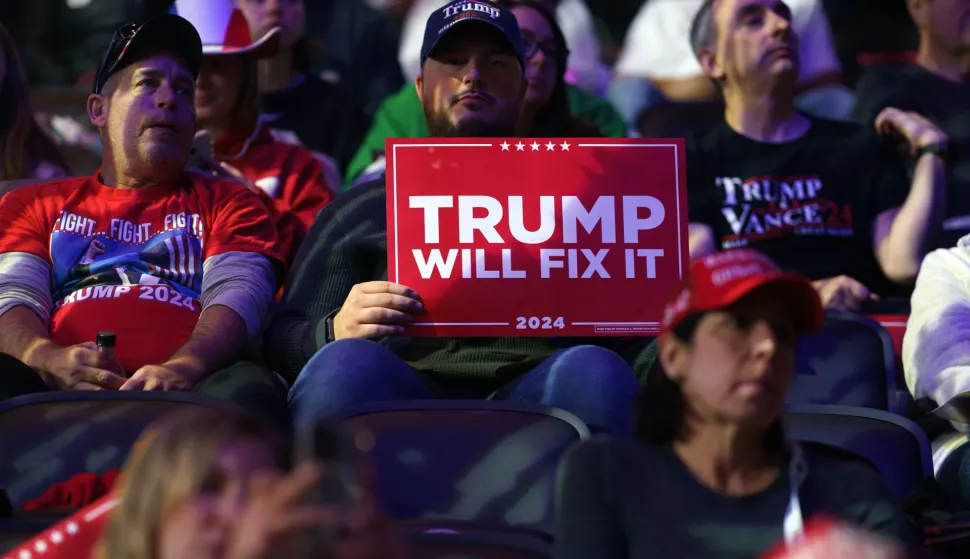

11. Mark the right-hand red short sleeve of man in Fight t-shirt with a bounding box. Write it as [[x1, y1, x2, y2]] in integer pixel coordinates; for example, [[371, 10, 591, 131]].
[[203, 181, 284, 262]]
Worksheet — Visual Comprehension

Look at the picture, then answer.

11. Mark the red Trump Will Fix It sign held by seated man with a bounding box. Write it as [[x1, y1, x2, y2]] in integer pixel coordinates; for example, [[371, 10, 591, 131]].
[[387, 138, 688, 337]]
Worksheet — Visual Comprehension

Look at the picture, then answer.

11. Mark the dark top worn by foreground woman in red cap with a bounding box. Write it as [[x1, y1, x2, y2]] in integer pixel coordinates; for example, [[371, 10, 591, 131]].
[[555, 437, 910, 559]]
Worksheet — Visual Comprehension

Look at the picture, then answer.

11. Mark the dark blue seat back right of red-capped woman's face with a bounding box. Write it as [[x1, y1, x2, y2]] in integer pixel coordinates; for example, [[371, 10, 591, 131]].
[[788, 312, 906, 413]]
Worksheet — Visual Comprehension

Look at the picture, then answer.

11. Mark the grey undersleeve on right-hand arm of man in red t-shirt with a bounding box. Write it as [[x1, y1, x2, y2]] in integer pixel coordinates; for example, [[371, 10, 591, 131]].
[[201, 252, 276, 340]]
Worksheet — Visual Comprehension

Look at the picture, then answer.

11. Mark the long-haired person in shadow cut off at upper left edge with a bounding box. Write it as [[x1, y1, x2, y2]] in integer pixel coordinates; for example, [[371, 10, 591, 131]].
[[0, 24, 68, 181]]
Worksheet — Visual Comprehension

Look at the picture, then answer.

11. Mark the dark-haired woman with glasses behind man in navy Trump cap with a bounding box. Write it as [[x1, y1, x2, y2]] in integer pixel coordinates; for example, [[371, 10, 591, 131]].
[[496, 0, 603, 138]]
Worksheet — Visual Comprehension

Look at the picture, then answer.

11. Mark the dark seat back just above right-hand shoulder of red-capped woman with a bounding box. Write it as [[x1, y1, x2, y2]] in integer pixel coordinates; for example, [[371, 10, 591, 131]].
[[782, 405, 933, 499]]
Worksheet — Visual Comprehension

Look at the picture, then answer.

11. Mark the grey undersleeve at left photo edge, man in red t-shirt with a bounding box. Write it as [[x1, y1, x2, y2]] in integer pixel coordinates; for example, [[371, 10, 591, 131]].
[[0, 252, 54, 324]]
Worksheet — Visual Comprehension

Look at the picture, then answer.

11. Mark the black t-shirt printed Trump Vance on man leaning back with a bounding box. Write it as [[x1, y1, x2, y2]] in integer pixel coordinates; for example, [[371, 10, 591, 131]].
[[687, 119, 909, 287]]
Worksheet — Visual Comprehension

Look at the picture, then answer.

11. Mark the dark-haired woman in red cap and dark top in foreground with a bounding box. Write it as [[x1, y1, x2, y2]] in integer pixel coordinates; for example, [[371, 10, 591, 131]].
[[555, 249, 906, 559]]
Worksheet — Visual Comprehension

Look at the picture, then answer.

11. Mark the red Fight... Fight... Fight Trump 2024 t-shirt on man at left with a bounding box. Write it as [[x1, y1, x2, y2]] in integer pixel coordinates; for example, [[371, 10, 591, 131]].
[[0, 173, 282, 372]]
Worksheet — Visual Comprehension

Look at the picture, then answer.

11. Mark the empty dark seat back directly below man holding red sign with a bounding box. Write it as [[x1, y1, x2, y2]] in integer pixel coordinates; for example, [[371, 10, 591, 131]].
[[332, 400, 589, 534]]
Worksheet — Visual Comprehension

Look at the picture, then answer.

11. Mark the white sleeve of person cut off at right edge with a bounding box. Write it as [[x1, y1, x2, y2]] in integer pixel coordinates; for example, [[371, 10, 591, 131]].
[[903, 244, 970, 405]]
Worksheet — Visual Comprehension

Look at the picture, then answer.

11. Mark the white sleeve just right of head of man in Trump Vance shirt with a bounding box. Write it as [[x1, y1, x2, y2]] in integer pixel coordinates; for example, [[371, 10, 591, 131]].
[[792, 0, 842, 82]]
